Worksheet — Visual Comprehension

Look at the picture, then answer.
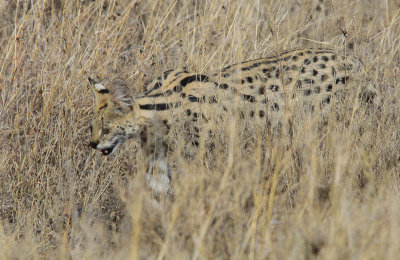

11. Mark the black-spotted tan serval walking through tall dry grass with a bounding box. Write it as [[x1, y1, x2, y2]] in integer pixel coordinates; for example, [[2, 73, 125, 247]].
[[89, 49, 376, 192]]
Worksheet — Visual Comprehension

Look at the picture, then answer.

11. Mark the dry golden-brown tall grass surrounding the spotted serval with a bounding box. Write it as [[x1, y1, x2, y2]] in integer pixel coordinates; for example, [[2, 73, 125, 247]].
[[0, 0, 400, 259]]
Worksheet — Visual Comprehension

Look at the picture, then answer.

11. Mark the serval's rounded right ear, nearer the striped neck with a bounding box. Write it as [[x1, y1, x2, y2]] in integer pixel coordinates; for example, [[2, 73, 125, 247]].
[[110, 79, 134, 110]]
